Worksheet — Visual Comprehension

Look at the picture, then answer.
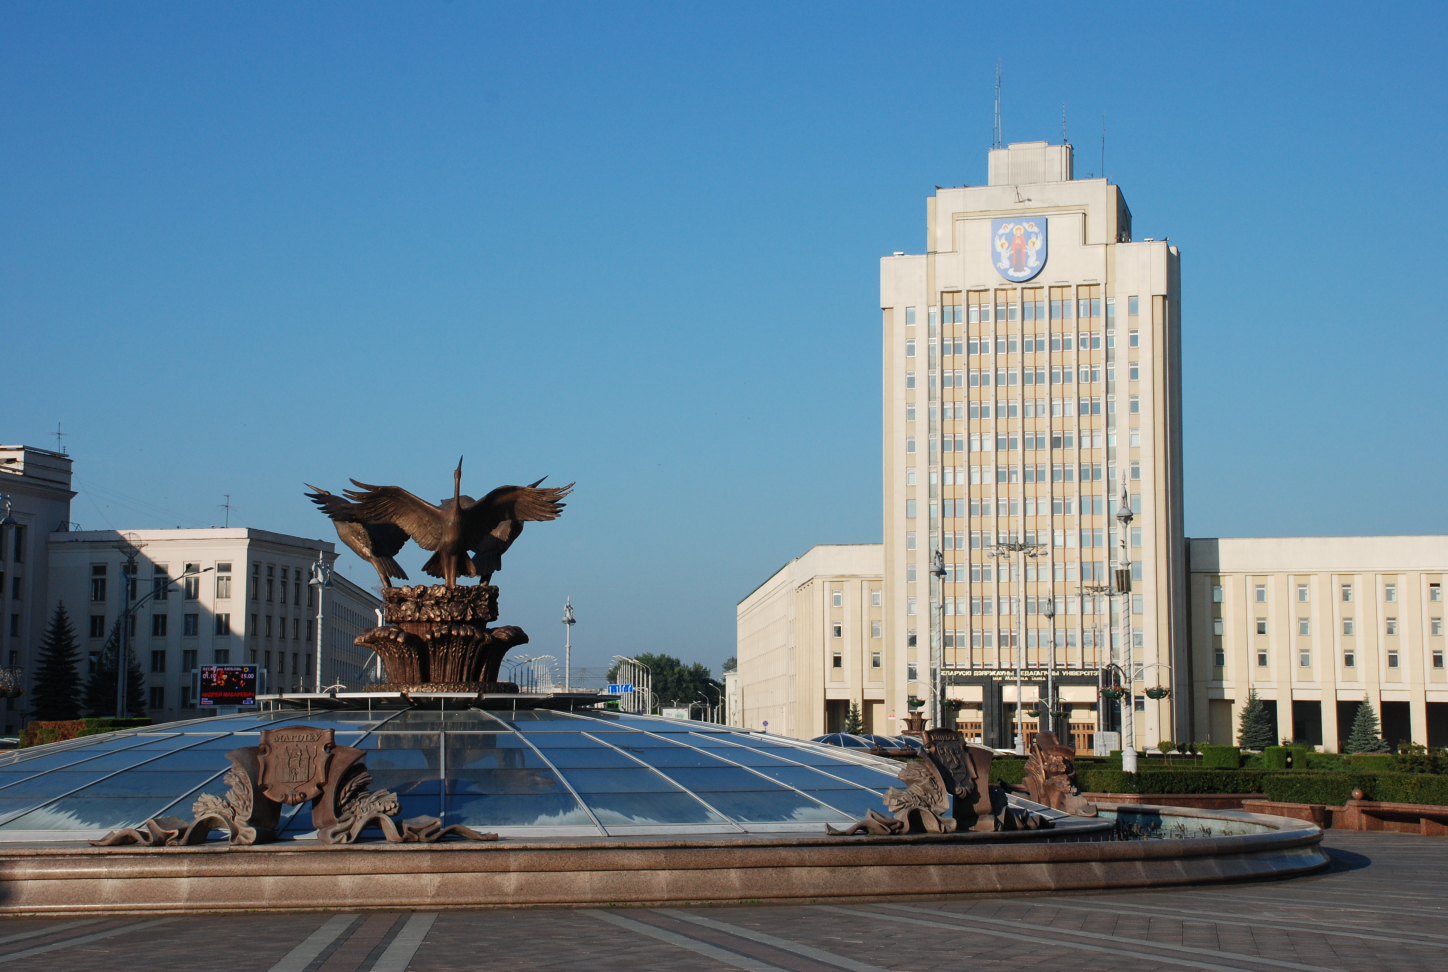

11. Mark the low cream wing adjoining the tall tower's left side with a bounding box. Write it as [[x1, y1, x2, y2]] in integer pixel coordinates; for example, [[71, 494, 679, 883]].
[[728, 543, 880, 739]]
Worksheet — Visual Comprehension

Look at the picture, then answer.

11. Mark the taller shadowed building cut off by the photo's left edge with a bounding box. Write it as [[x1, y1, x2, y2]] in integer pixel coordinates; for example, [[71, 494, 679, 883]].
[[0, 446, 75, 736]]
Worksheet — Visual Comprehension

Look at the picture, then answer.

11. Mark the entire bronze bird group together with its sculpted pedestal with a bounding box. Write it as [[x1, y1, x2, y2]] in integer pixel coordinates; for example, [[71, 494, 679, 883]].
[[307, 459, 573, 692]]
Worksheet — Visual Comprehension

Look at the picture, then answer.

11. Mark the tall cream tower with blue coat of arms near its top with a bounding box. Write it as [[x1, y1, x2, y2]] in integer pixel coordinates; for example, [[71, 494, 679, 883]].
[[874, 142, 1189, 747]]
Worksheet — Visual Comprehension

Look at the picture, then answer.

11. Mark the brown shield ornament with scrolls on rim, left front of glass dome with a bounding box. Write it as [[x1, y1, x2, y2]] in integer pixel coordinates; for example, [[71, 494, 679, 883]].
[[90, 726, 498, 847]]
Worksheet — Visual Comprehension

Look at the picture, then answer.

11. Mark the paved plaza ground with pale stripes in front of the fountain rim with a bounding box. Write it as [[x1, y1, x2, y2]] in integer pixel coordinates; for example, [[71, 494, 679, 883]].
[[0, 831, 1448, 972]]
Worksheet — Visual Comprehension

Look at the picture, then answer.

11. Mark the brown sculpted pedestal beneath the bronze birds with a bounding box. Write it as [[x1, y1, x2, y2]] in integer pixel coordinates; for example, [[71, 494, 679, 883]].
[[353, 584, 529, 692]]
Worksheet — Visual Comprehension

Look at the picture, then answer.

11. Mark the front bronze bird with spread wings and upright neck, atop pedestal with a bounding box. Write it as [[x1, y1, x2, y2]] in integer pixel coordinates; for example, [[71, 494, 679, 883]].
[[338, 459, 573, 587]]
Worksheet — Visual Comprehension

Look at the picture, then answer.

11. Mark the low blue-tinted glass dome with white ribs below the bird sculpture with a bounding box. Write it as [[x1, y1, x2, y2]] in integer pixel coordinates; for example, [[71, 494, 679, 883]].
[[0, 708, 899, 842]]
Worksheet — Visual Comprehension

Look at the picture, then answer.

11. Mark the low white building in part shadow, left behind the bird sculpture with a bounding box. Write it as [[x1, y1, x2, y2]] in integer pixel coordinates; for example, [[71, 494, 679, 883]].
[[46, 527, 382, 721]]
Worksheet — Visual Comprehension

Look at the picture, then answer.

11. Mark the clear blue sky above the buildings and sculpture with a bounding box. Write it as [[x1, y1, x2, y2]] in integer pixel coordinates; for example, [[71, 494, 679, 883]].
[[0, 1, 1448, 680]]
